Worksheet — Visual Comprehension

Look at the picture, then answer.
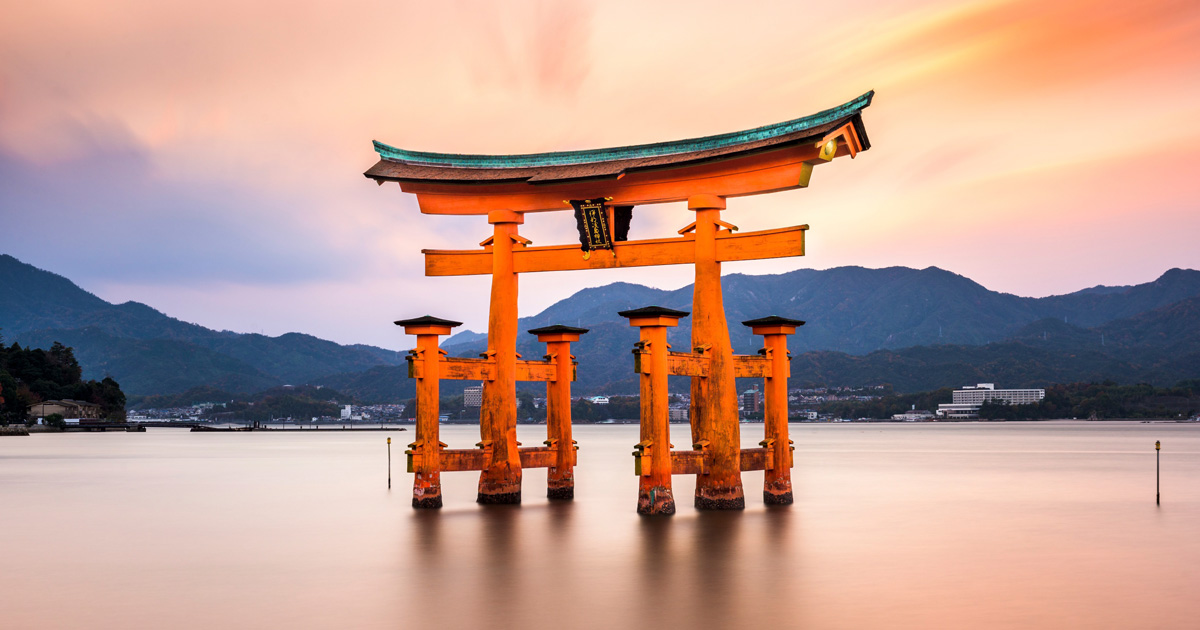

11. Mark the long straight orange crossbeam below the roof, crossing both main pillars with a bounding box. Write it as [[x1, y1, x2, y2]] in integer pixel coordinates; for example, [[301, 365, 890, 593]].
[[421, 226, 809, 276]]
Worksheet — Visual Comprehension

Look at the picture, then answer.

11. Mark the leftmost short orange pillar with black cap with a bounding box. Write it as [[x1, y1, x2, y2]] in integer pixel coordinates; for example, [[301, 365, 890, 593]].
[[396, 316, 462, 508]]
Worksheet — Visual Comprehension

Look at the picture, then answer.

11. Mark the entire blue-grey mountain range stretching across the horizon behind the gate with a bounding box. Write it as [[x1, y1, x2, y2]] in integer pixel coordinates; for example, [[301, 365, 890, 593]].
[[0, 250, 1200, 401]]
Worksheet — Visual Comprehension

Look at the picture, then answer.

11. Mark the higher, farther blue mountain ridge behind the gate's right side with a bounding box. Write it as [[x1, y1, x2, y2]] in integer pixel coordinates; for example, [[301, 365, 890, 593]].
[[482, 266, 1200, 354]]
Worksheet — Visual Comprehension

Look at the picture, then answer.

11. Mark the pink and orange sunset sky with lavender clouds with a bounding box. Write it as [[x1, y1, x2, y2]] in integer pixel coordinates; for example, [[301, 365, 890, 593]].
[[0, 0, 1200, 348]]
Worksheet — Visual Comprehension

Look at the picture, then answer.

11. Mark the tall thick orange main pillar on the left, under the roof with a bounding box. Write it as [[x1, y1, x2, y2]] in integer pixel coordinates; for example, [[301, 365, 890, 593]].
[[475, 210, 524, 503]]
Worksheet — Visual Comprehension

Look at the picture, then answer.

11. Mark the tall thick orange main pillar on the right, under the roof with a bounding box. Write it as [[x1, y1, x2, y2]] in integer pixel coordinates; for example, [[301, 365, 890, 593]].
[[688, 194, 745, 510]]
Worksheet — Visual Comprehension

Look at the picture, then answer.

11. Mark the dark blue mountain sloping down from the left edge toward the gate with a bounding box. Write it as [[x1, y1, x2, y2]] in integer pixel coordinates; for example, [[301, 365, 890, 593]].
[[0, 254, 403, 395]]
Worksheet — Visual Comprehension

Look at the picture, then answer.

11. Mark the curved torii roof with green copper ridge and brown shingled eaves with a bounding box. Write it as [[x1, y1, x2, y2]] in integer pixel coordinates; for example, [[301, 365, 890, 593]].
[[364, 91, 875, 184]]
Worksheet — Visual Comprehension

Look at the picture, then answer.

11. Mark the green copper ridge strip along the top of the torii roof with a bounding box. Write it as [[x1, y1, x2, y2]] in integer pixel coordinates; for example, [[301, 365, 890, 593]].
[[374, 91, 875, 168]]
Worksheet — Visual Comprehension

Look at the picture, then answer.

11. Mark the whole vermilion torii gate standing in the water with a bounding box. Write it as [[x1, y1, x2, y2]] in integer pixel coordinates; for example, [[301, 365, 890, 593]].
[[365, 92, 874, 514]]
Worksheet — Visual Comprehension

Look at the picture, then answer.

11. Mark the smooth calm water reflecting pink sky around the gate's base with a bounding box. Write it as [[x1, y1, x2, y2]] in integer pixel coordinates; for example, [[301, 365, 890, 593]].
[[0, 422, 1200, 629]]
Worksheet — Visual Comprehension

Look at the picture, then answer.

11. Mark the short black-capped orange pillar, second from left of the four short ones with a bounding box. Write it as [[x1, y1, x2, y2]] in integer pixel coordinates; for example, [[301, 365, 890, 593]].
[[529, 325, 588, 499]]
